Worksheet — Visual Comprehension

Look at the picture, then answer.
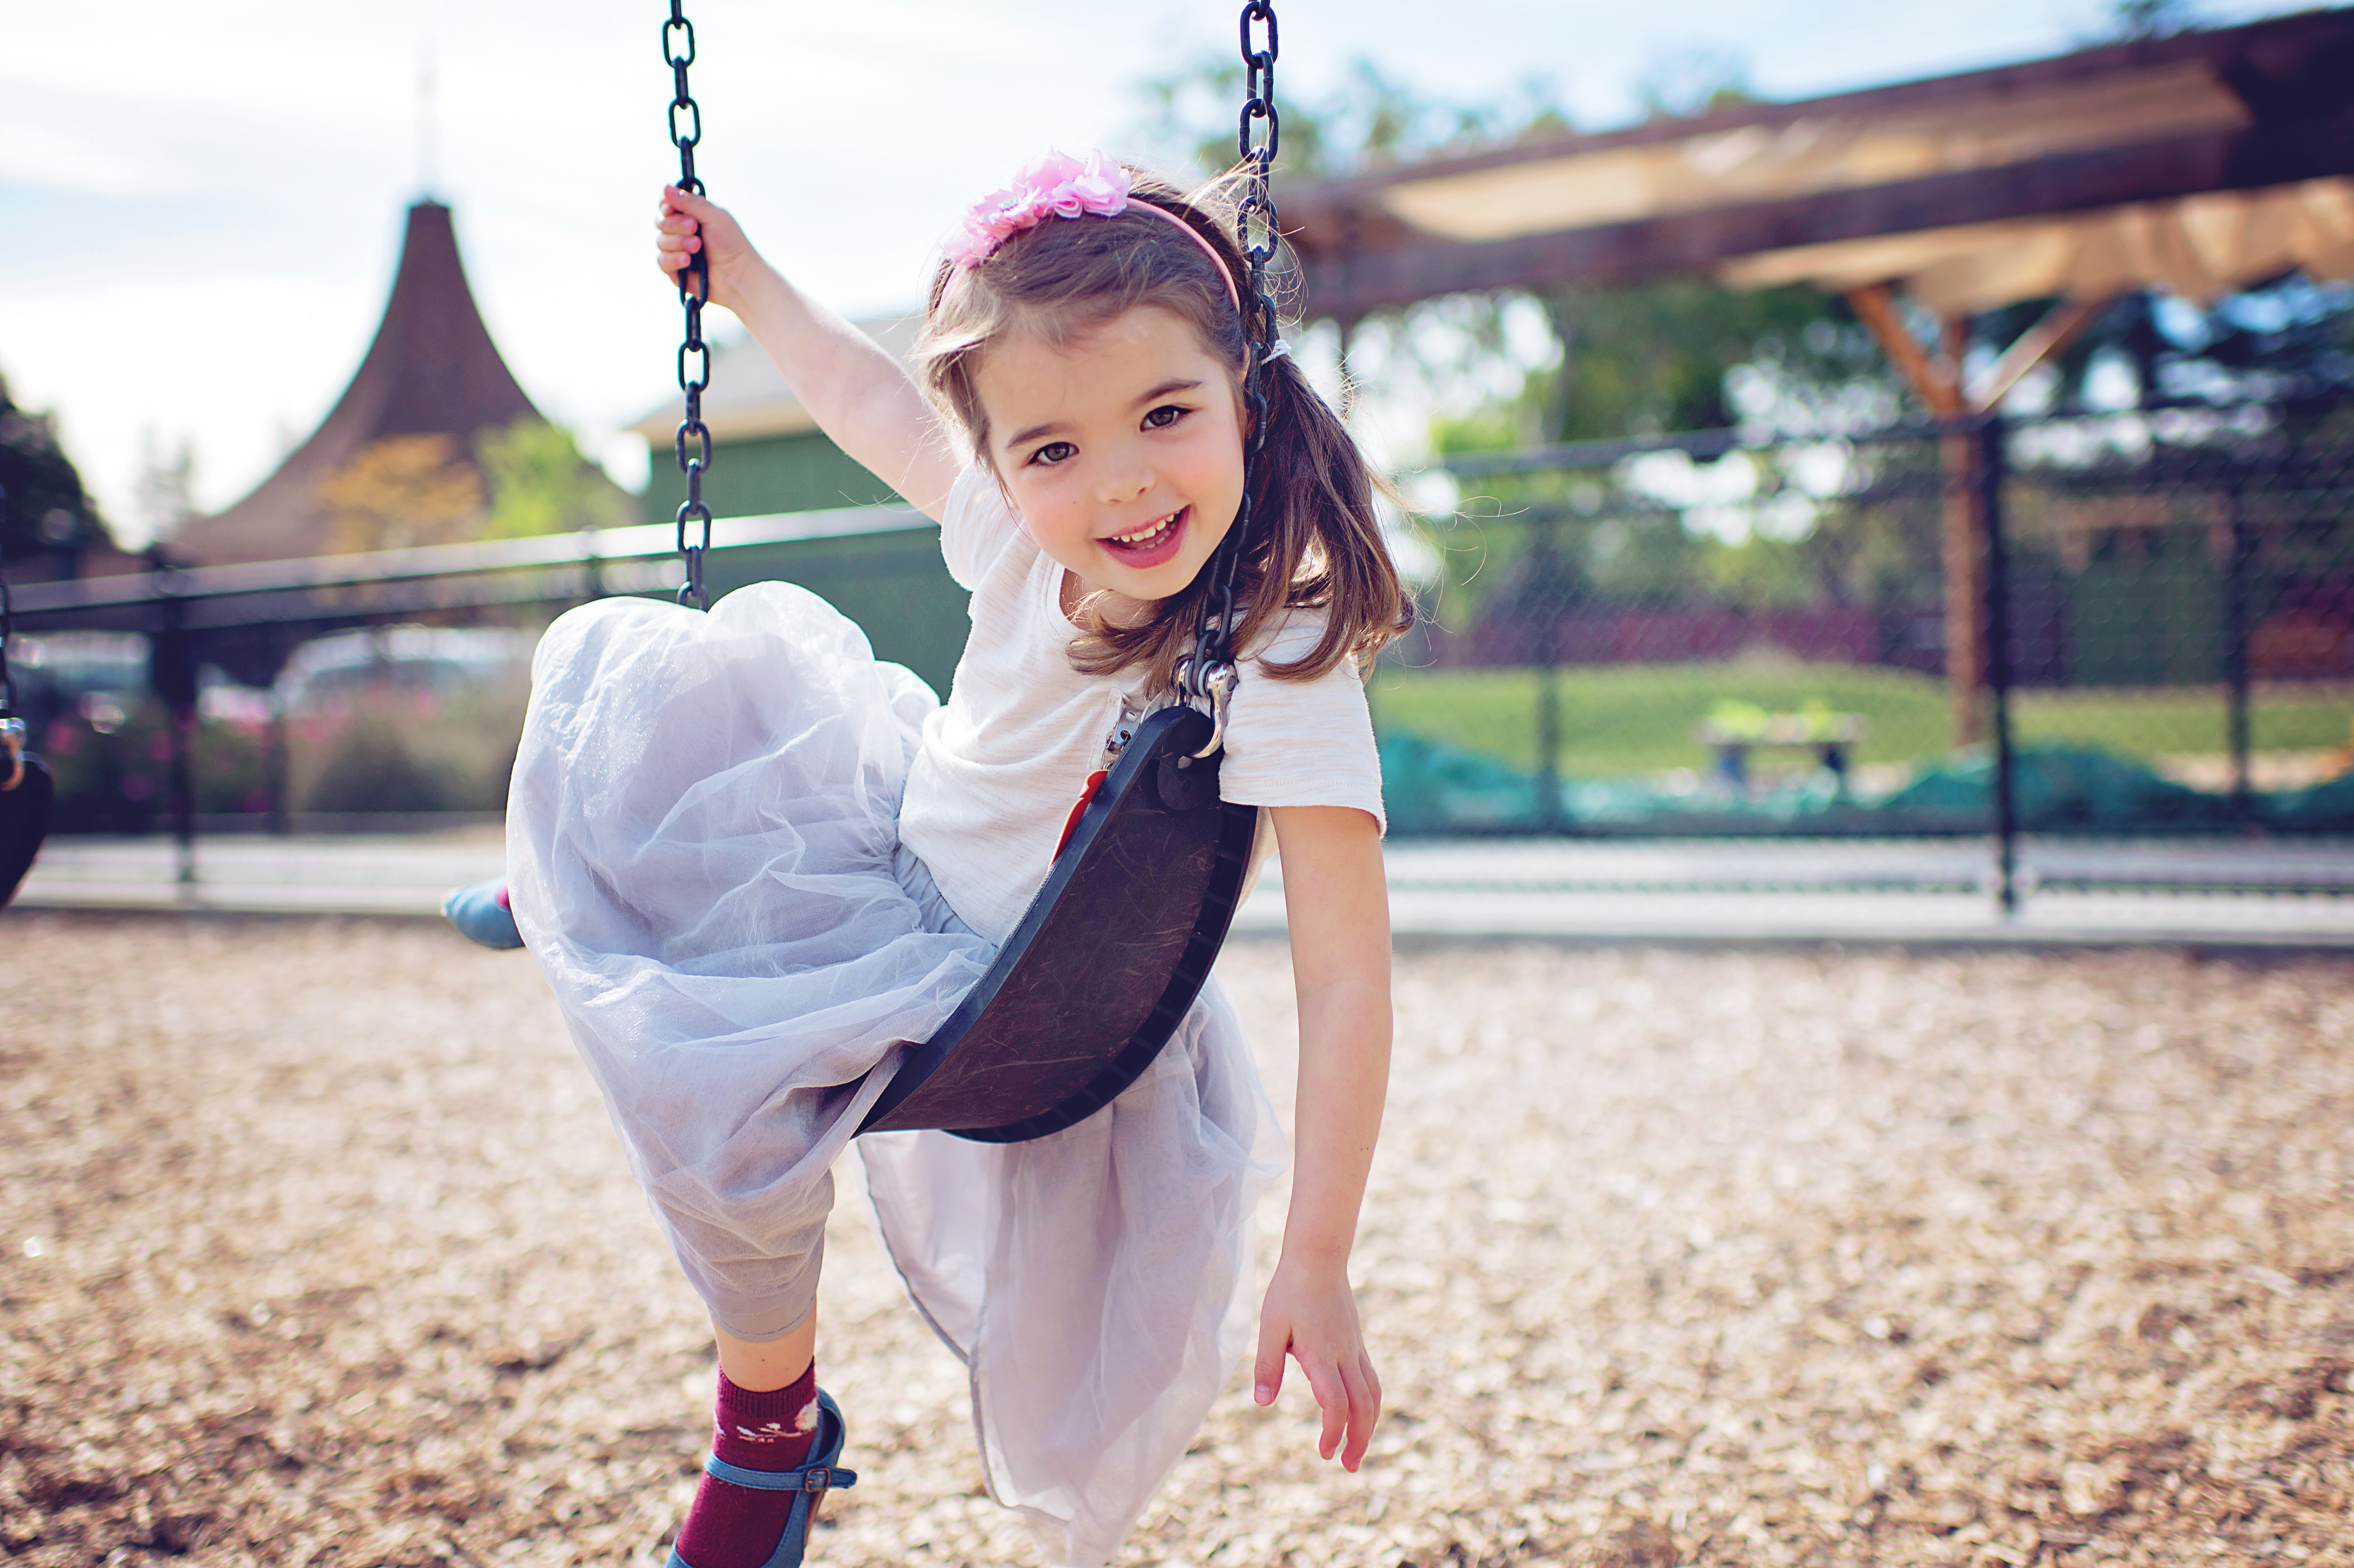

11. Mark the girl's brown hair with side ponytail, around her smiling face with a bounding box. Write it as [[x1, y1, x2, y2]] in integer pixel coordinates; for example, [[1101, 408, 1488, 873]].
[[923, 164, 1415, 690]]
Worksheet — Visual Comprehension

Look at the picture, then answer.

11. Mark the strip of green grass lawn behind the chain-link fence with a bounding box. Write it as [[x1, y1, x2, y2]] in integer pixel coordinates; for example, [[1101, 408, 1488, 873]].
[[1373, 664, 2354, 777]]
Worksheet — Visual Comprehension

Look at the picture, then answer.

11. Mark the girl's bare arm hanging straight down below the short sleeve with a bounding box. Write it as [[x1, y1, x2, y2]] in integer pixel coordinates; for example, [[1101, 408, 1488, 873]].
[[1252, 805, 1389, 1472]]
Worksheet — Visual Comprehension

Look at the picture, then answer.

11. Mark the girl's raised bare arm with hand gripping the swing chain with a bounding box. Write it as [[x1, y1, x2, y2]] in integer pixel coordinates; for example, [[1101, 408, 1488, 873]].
[[654, 186, 963, 523]]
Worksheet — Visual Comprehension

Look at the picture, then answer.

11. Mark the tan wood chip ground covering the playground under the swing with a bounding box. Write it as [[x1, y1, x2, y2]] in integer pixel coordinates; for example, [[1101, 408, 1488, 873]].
[[0, 913, 2354, 1568]]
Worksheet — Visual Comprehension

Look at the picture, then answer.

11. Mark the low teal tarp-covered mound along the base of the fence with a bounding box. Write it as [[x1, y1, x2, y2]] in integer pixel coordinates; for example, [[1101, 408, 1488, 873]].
[[1382, 732, 2354, 833]]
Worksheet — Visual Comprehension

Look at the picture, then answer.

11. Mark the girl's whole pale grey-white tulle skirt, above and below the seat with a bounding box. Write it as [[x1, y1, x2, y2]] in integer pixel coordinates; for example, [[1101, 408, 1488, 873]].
[[506, 584, 1280, 1568]]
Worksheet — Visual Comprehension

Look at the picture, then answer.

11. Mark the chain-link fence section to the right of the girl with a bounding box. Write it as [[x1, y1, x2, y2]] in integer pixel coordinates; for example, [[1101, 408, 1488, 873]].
[[1373, 403, 2354, 836]]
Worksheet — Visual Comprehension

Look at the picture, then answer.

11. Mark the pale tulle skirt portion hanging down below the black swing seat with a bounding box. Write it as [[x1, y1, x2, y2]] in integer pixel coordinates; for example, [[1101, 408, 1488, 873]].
[[859, 980, 1283, 1568]]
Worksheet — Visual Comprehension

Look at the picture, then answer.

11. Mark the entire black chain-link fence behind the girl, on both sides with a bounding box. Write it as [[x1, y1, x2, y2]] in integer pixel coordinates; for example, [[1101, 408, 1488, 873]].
[[19, 403, 2354, 904]]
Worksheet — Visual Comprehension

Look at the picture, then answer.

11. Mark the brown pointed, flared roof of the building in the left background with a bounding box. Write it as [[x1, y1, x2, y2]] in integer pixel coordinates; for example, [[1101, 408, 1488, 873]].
[[167, 200, 539, 565]]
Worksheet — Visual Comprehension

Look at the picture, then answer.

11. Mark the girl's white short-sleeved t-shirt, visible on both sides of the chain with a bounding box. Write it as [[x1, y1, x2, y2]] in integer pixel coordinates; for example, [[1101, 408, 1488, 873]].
[[899, 464, 1389, 942]]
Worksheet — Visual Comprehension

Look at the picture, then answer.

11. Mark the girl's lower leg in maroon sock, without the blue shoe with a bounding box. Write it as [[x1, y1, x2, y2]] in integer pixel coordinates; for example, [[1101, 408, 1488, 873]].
[[678, 1307, 817, 1568]]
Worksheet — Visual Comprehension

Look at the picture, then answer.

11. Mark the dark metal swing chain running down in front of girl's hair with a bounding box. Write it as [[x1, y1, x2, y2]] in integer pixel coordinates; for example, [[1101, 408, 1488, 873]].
[[1177, 0, 1283, 725]]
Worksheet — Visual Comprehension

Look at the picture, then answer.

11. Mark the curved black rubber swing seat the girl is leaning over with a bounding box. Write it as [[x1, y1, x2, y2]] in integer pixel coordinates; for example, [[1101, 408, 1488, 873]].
[[859, 706, 1259, 1144]]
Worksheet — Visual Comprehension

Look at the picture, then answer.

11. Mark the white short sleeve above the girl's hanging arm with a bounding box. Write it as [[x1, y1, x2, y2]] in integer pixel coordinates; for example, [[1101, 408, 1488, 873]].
[[1217, 614, 1389, 831]]
